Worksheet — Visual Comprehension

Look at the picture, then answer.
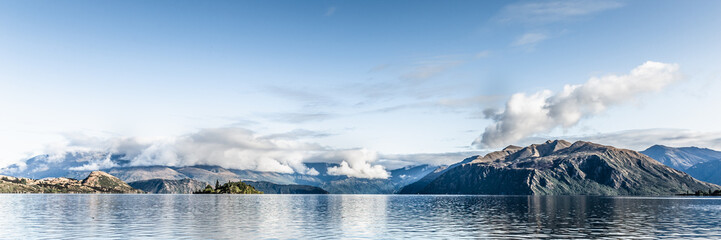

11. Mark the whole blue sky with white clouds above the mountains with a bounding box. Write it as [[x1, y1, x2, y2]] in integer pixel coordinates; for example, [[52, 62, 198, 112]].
[[0, 1, 721, 178]]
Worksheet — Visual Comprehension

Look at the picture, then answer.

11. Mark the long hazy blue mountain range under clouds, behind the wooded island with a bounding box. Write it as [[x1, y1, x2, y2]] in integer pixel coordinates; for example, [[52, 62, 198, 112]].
[[0, 152, 438, 194]]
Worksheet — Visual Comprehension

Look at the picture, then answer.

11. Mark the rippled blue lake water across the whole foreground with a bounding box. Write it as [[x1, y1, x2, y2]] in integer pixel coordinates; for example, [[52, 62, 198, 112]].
[[0, 194, 721, 239]]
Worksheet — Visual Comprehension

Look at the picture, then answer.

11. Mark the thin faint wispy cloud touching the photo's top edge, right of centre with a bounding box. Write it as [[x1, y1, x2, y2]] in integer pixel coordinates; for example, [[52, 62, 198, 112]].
[[497, 0, 623, 24]]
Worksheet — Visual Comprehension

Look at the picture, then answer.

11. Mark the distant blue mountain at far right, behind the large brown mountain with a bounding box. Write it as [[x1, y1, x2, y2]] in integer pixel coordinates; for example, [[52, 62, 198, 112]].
[[641, 145, 721, 171]]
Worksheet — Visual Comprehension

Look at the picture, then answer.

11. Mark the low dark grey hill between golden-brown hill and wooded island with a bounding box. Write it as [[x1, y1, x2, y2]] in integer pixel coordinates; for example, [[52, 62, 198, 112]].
[[128, 178, 208, 194]]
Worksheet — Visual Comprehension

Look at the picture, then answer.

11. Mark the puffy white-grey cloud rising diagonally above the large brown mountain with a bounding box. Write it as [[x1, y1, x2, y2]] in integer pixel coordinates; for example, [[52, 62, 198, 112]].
[[473, 61, 680, 147]]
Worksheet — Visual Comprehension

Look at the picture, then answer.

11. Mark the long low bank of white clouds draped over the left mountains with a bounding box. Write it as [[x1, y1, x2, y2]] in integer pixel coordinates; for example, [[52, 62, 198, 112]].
[[53, 128, 388, 178]]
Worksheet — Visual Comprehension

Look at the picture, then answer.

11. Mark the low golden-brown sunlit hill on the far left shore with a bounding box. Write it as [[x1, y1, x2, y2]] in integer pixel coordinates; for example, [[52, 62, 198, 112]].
[[0, 171, 143, 193]]
